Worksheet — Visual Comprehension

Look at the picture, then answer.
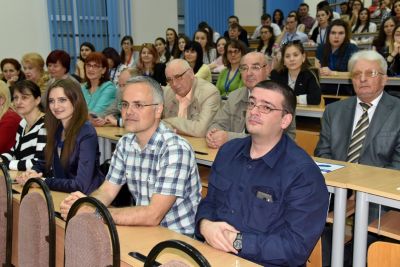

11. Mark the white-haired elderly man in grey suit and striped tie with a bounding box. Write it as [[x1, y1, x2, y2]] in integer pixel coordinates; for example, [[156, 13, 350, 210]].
[[315, 50, 400, 169]]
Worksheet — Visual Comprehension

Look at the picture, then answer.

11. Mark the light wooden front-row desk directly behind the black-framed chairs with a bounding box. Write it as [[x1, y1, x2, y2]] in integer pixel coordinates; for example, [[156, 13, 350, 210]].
[[11, 172, 259, 267]]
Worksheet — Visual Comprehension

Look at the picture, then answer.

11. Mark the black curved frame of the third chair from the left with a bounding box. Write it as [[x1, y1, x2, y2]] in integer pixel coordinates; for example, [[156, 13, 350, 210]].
[[64, 197, 121, 267]]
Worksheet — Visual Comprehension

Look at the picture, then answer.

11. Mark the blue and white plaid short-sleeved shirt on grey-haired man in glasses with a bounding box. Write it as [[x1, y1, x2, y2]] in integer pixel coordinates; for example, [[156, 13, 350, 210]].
[[106, 123, 201, 235]]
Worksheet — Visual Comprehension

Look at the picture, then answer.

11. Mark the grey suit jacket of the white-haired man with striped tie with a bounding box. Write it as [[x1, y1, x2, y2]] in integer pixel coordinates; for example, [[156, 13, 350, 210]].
[[314, 92, 400, 169]]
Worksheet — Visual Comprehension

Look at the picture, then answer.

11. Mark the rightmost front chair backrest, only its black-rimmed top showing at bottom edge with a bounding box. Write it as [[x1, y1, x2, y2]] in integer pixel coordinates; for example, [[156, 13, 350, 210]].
[[144, 240, 211, 267]]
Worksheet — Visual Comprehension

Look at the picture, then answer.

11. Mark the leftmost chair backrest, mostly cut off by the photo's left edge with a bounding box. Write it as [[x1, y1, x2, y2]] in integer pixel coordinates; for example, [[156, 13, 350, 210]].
[[0, 163, 13, 266]]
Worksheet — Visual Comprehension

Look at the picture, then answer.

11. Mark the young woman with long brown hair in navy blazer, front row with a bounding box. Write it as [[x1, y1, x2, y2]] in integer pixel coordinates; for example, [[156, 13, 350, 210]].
[[17, 79, 104, 194]]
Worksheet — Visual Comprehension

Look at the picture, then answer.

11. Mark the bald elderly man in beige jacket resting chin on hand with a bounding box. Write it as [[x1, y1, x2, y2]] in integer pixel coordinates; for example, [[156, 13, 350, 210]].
[[163, 59, 221, 137]]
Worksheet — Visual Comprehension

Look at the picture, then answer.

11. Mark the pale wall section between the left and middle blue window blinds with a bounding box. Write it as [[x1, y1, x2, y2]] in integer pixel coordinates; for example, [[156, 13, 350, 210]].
[[132, 0, 178, 45]]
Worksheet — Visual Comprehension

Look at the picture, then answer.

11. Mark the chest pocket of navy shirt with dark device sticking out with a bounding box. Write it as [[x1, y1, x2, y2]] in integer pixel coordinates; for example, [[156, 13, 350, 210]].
[[242, 186, 281, 232]]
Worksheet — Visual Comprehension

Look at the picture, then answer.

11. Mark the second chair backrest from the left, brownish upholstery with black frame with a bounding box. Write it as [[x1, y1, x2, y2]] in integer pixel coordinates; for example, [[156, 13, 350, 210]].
[[18, 178, 56, 267]]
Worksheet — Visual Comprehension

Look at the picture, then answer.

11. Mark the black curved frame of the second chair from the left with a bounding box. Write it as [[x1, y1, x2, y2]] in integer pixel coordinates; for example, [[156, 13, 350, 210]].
[[21, 178, 56, 267]]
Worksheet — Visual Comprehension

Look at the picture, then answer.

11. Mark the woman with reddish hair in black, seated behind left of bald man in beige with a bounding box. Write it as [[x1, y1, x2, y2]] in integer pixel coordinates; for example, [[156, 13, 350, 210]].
[[134, 43, 167, 86]]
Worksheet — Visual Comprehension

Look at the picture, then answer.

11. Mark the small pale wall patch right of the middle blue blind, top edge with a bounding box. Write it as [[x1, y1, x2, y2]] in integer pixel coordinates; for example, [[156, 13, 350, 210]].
[[235, 0, 262, 26]]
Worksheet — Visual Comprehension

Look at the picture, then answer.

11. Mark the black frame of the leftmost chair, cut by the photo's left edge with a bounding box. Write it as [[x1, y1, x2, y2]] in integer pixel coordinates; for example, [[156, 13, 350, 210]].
[[0, 163, 13, 266]]
